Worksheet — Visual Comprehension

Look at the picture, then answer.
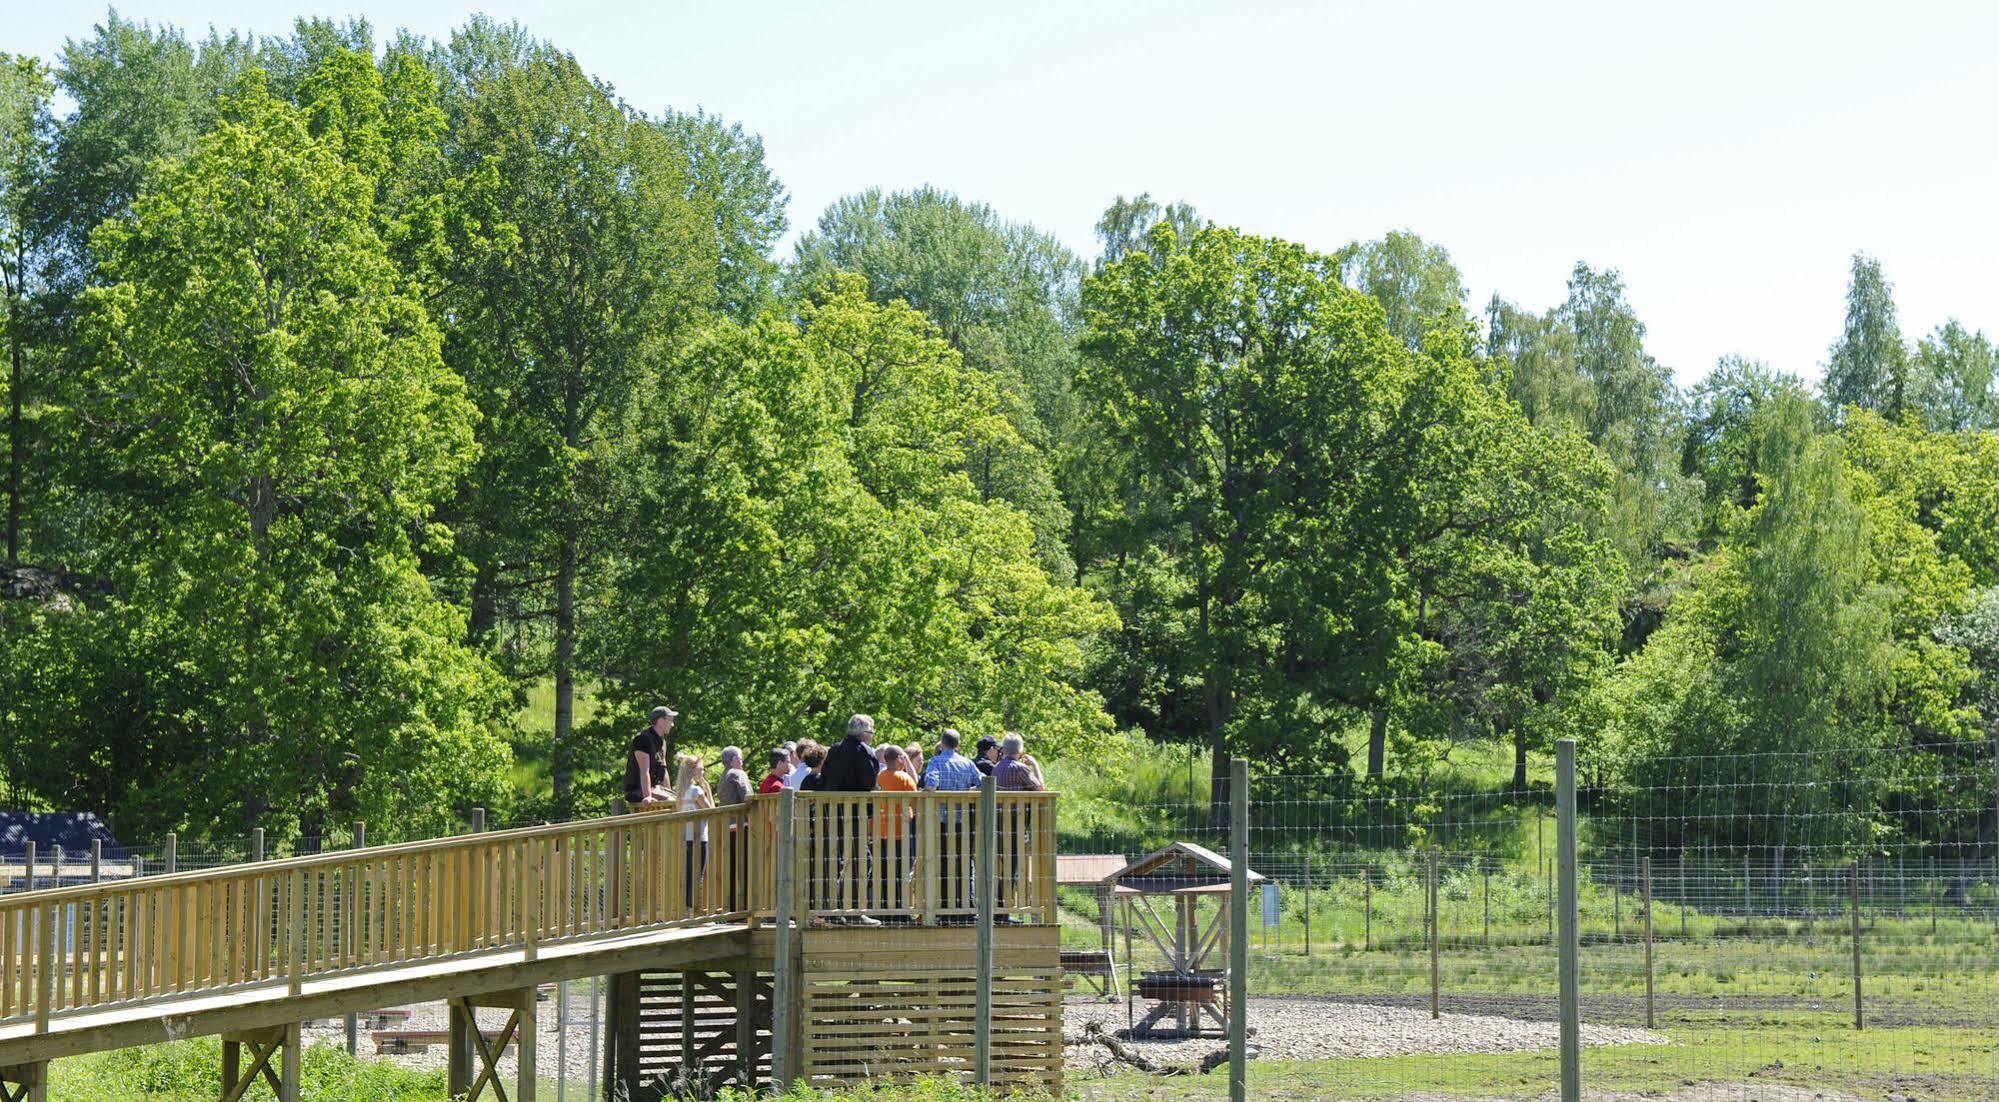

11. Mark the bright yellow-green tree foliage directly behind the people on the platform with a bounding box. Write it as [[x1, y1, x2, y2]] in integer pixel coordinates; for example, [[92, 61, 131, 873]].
[[602, 276, 1115, 752]]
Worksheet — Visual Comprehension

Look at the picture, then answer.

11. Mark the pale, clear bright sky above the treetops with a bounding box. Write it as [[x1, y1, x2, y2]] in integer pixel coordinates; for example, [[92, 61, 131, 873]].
[[15, 0, 1999, 382]]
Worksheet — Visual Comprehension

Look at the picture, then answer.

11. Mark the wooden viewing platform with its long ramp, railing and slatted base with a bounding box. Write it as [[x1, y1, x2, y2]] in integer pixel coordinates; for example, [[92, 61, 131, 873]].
[[0, 792, 1061, 1102]]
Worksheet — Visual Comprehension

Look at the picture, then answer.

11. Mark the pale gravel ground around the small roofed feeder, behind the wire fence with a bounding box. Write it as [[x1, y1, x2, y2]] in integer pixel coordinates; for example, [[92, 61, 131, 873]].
[[1065, 998, 1669, 1068]]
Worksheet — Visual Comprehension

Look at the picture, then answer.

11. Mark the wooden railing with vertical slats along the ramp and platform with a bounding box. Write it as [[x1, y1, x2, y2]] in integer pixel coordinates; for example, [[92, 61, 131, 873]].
[[0, 792, 1055, 1030]]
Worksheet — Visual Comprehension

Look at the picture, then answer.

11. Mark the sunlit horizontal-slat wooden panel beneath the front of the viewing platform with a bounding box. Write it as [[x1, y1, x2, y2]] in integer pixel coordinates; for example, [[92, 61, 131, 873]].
[[802, 968, 1061, 1092]]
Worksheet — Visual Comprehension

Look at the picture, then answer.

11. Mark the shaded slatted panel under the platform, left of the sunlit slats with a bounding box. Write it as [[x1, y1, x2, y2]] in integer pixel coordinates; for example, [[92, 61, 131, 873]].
[[638, 972, 772, 1098]]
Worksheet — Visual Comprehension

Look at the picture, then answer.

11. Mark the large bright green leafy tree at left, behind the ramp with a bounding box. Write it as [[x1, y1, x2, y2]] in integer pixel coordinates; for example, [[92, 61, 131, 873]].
[[78, 70, 506, 834]]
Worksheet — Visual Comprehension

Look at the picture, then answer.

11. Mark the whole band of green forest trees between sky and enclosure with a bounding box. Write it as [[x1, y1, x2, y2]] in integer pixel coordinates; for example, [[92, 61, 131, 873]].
[[0, 14, 1999, 860]]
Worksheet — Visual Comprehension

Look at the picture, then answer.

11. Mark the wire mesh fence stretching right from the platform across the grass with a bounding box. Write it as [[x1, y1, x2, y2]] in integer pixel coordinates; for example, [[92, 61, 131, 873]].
[[1063, 754, 1999, 1098]]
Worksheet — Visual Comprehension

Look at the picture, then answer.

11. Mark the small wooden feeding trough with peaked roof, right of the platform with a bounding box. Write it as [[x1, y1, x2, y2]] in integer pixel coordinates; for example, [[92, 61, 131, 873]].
[[1101, 842, 1263, 1038]]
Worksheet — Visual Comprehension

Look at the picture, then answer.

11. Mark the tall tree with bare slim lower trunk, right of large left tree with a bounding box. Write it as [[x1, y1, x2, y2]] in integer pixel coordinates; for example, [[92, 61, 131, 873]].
[[440, 34, 718, 800]]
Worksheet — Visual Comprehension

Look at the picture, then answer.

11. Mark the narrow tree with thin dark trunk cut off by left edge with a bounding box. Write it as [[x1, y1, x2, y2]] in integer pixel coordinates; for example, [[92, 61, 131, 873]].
[[0, 54, 54, 564]]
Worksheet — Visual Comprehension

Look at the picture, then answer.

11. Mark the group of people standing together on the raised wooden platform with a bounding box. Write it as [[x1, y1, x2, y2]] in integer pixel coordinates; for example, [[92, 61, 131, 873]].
[[624, 704, 1045, 926]]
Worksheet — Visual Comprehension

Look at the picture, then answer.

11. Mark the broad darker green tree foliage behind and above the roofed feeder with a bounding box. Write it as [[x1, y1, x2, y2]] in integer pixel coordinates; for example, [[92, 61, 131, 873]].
[[1079, 224, 1623, 798]]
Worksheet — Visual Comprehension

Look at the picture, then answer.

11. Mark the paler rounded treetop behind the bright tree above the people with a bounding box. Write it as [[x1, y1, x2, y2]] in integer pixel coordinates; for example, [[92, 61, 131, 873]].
[[790, 188, 1081, 574]]
